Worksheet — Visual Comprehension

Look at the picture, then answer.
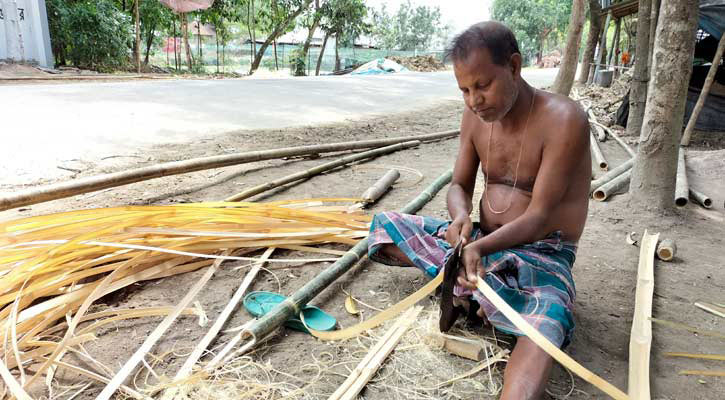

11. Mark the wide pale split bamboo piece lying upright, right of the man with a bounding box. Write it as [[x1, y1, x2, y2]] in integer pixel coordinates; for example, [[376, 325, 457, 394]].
[[627, 230, 659, 400]]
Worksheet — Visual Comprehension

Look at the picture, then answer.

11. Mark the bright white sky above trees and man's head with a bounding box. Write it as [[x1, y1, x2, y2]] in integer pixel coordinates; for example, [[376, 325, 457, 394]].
[[365, 0, 491, 34]]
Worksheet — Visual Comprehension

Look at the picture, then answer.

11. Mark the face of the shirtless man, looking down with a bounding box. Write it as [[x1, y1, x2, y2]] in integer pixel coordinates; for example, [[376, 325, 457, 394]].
[[453, 49, 518, 122]]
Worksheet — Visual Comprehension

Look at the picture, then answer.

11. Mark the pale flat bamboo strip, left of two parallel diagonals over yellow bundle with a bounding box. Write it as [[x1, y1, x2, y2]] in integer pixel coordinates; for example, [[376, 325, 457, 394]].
[[96, 250, 229, 400]]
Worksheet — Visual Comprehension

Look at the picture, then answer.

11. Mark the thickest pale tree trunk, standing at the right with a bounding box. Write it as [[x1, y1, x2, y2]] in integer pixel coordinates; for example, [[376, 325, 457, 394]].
[[630, 0, 698, 210]]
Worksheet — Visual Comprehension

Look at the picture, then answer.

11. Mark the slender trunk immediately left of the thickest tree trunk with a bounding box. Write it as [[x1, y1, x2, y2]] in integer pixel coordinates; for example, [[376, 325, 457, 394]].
[[627, 0, 652, 137]]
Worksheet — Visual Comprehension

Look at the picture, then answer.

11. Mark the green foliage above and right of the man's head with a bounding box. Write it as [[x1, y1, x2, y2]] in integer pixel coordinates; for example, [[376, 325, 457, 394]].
[[491, 0, 572, 63]]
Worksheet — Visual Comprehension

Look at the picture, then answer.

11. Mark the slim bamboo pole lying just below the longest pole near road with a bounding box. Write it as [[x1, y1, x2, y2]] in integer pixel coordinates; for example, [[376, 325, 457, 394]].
[[224, 140, 420, 201]]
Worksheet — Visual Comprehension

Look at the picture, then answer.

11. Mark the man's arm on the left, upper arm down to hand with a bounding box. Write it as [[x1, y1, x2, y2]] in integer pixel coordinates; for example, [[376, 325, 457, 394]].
[[446, 108, 480, 245]]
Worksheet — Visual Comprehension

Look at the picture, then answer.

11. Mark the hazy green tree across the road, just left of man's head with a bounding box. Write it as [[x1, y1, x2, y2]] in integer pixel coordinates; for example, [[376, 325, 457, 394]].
[[372, 0, 450, 51]]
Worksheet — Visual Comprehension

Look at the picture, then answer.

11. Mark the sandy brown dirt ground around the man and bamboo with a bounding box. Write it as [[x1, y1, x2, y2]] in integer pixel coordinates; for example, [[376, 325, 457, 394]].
[[0, 97, 725, 400]]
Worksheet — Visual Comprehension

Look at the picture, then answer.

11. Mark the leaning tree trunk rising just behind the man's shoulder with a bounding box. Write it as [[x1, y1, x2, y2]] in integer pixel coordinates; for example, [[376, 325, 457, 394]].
[[552, 0, 586, 96]]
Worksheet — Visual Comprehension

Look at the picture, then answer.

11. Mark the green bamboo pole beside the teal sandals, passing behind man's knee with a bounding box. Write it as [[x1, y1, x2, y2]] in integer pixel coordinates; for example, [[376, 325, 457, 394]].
[[243, 170, 453, 350]]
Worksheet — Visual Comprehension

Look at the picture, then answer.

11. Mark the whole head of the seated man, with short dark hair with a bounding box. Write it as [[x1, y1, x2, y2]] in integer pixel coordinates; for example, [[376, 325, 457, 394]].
[[446, 21, 521, 122]]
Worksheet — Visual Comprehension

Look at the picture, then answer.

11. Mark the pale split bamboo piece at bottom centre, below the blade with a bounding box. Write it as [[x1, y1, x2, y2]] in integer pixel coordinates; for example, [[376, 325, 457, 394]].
[[328, 306, 423, 400]]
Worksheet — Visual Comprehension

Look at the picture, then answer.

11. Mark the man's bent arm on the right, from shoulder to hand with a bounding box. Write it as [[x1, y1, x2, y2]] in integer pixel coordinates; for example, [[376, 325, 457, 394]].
[[461, 101, 589, 286]]
